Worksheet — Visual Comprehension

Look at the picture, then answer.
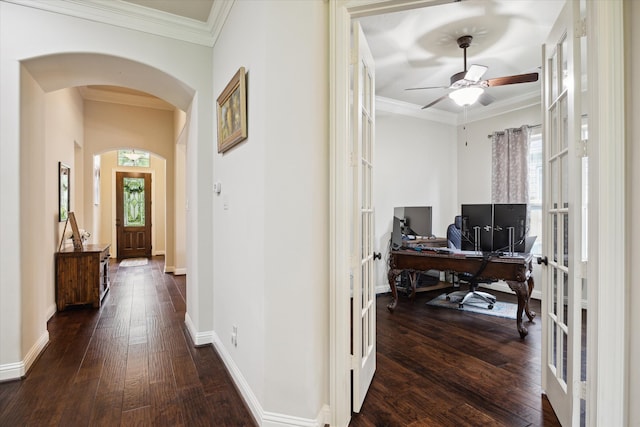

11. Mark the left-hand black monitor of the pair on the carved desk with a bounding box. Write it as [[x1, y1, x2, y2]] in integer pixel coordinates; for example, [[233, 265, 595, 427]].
[[460, 204, 493, 252]]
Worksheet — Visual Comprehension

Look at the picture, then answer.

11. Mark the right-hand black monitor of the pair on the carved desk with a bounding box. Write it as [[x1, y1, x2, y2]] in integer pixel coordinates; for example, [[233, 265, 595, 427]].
[[493, 203, 527, 252]]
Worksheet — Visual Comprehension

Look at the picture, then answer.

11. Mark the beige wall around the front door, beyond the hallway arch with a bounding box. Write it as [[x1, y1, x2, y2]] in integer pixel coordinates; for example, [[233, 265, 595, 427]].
[[84, 101, 184, 272]]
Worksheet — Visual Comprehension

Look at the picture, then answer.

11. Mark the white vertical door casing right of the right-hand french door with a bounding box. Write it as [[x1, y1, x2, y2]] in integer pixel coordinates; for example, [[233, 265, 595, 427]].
[[585, 0, 631, 425]]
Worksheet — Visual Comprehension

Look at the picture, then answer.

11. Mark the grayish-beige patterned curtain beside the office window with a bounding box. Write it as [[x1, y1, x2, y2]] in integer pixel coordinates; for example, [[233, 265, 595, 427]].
[[491, 125, 531, 203]]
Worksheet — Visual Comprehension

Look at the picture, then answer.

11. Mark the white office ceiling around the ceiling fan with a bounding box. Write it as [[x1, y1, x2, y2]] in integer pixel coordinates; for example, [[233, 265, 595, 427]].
[[359, 0, 564, 112]]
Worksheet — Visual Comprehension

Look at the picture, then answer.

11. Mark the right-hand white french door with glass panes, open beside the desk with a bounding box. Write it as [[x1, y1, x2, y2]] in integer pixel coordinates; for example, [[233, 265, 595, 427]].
[[542, 0, 586, 426]]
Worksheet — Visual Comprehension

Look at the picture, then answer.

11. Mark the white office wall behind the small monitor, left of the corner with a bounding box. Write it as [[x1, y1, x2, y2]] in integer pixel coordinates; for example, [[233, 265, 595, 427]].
[[373, 112, 458, 292]]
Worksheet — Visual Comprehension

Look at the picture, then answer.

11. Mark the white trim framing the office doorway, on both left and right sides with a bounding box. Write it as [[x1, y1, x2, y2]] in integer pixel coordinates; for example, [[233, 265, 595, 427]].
[[329, 0, 629, 426]]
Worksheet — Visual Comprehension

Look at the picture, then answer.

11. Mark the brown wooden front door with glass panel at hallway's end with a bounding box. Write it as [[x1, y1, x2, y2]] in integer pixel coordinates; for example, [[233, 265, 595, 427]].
[[116, 172, 151, 259]]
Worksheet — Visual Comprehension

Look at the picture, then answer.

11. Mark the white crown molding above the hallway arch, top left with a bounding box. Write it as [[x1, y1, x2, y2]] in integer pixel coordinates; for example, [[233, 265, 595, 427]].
[[4, 0, 229, 47]]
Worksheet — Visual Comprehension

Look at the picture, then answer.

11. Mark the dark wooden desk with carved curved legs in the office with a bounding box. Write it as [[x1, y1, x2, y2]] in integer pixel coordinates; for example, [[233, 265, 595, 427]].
[[387, 249, 536, 338]]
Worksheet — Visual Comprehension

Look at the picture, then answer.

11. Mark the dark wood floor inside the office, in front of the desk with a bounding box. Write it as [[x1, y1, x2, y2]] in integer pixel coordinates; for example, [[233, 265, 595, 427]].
[[350, 284, 560, 427]]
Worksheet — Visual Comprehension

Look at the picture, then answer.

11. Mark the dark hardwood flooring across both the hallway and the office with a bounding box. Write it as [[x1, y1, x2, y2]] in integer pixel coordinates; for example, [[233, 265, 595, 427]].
[[0, 258, 559, 427]]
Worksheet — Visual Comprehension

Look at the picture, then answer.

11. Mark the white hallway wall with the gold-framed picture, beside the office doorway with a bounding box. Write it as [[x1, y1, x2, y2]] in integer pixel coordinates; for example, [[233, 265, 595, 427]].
[[211, 1, 329, 425]]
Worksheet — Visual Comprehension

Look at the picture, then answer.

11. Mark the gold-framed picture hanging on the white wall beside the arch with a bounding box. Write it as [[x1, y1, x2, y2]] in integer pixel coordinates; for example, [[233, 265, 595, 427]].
[[216, 67, 247, 153]]
